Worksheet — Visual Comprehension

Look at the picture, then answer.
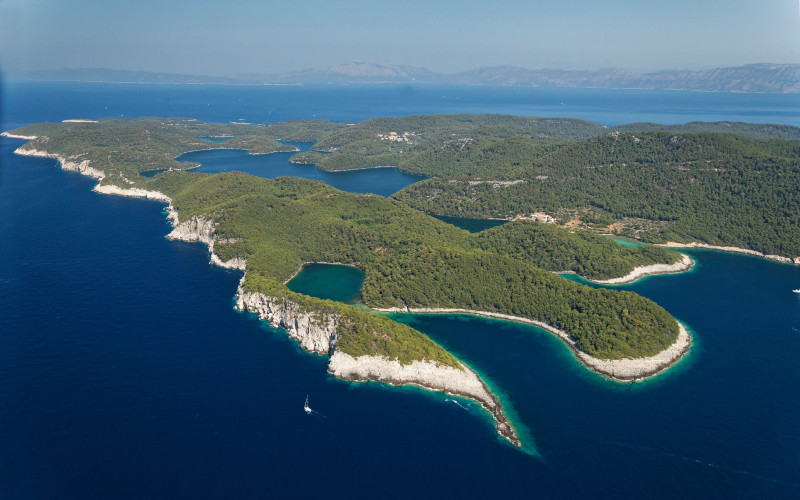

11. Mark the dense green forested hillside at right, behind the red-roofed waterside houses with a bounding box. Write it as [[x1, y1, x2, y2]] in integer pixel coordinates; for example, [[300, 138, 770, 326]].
[[395, 132, 800, 257]]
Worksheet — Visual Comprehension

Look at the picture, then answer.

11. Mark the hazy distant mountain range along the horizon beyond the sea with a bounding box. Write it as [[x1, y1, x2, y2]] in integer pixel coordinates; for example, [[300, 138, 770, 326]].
[[12, 62, 800, 93]]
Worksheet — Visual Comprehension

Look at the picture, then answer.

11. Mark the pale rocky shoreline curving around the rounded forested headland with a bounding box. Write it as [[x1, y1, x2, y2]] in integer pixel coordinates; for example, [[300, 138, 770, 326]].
[[373, 307, 692, 382]]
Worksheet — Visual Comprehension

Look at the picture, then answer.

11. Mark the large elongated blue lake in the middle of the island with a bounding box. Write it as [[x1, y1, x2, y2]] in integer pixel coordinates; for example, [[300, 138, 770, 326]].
[[172, 141, 425, 196]]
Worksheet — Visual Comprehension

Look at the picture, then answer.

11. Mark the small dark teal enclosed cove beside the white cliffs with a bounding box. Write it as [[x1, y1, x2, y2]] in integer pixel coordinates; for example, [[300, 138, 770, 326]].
[[286, 264, 364, 305]]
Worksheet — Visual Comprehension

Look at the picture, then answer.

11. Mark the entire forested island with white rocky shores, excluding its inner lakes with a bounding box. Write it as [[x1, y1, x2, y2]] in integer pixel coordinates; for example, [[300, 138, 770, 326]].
[[4, 115, 800, 446]]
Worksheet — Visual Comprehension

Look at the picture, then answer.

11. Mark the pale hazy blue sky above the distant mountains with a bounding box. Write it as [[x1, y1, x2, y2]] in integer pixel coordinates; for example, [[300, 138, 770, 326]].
[[0, 0, 800, 74]]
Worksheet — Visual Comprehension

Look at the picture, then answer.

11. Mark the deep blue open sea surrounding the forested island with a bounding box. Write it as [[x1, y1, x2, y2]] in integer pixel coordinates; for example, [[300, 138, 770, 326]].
[[0, 82, 800, 499]]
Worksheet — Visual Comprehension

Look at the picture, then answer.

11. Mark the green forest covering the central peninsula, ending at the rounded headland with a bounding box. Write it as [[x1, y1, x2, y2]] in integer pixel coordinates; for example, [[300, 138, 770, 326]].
[[155, 172, 678, 359]]
